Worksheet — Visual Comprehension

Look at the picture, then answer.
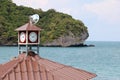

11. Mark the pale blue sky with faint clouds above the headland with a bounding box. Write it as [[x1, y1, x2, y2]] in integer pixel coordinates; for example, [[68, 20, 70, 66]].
[[13, 0, 120, 41]]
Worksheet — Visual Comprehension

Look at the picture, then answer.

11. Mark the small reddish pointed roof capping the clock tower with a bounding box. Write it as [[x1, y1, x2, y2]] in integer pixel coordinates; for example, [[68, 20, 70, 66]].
[[16, 22, 41, 31]]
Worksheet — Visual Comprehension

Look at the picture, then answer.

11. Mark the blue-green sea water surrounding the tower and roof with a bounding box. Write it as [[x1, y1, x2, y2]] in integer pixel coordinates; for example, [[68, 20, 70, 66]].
[[0, 41, 120, 80]]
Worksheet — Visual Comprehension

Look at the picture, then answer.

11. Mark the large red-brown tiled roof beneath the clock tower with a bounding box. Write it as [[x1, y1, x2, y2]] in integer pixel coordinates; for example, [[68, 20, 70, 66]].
[[0, 53, 96, 80]]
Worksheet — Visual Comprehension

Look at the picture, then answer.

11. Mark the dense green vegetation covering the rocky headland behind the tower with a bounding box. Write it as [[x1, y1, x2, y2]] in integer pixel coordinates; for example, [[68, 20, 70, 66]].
[[0, 0, 88, 44]]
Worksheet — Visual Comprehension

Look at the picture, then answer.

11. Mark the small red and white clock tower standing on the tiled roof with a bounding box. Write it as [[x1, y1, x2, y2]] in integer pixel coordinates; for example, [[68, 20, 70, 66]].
[[16, 14, 41, 54]]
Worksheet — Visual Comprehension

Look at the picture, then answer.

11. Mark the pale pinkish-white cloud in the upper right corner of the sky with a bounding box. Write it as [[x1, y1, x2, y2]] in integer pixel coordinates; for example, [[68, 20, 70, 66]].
[[83, 0, 120, 22]]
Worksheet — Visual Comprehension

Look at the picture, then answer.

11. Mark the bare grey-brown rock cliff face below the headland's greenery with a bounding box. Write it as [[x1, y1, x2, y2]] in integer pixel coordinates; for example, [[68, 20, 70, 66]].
[[43, 32, 89, 47]]
